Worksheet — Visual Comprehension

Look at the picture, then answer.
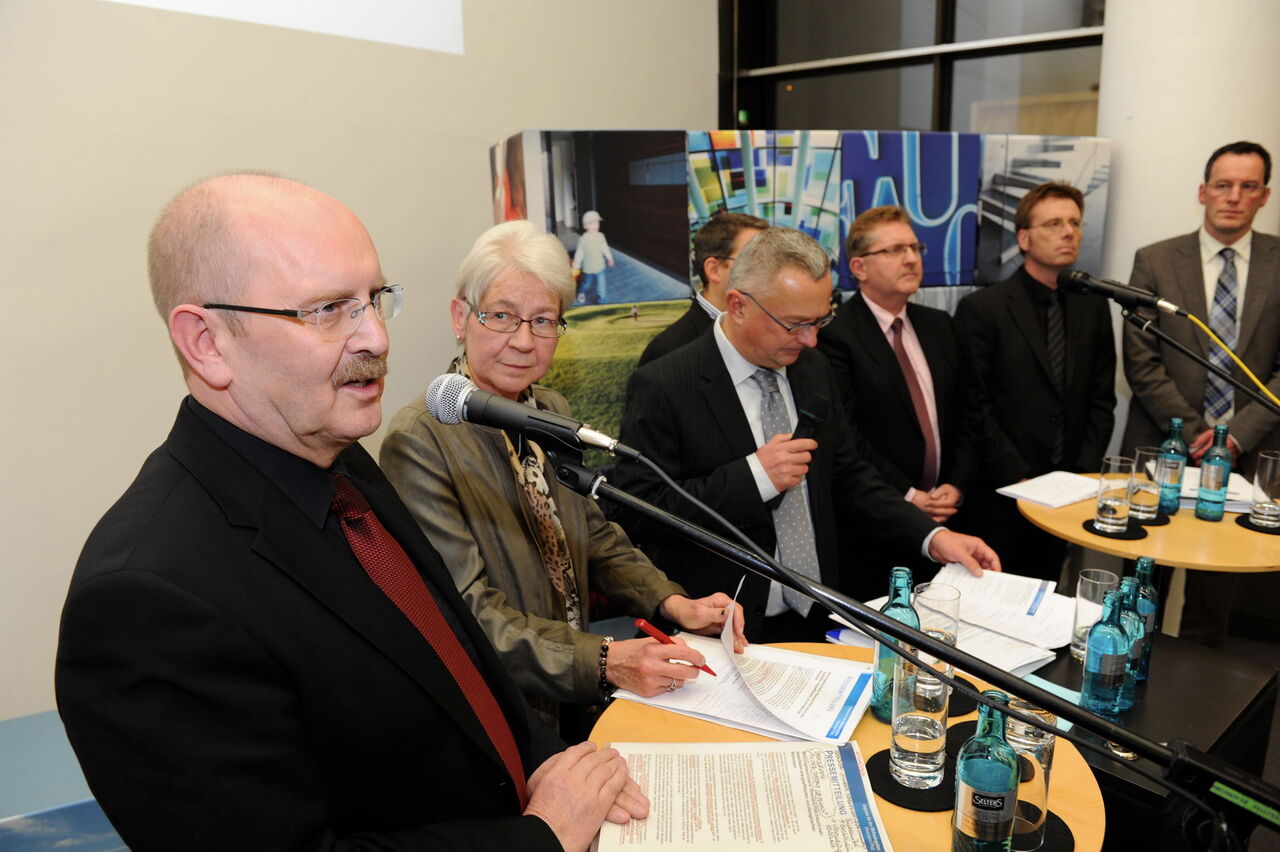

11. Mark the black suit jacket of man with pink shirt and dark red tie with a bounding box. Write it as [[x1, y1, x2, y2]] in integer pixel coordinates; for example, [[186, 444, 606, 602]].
[[818, 294, 973, 494]]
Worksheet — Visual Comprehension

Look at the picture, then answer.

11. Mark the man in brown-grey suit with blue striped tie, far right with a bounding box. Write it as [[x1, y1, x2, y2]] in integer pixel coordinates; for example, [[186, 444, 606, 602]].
[[1121, 142, 1280, 646]]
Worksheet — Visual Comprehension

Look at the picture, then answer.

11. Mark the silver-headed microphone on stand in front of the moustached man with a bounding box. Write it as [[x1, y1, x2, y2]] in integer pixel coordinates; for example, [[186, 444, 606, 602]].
[[426, 372, 640, 459]]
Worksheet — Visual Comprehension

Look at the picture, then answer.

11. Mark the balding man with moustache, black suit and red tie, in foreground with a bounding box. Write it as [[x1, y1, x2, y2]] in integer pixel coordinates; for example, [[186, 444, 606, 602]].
[[56, 175, 648, 852]]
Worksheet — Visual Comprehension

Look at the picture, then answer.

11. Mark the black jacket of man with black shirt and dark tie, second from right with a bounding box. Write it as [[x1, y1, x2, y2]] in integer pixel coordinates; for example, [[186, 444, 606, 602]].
[[955, 267, 1116, 487]]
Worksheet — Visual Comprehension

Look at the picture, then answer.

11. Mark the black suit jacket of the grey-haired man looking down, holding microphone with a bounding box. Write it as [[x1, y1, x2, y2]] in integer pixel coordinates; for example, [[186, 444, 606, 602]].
[[614, 334, 937, 636]]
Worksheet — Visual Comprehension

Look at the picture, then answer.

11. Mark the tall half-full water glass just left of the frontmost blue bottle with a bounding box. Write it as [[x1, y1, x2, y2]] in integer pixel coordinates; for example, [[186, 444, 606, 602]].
[[888, 651, 951, 789]]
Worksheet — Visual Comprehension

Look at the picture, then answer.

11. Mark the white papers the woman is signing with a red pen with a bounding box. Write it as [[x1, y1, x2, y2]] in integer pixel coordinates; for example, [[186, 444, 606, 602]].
[[613, 606, 872, 745]]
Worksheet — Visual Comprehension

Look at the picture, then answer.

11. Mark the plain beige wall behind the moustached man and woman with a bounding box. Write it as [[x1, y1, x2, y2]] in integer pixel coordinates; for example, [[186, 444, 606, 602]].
[[0, 0, 717, 719]]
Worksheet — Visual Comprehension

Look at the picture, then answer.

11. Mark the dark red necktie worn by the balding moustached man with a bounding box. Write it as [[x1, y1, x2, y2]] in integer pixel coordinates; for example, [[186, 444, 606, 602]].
[[333, 473, 529, 810]]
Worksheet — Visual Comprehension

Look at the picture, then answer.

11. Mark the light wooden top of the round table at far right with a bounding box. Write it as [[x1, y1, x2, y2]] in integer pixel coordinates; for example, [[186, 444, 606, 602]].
[[1018, 488, 1280, 572]]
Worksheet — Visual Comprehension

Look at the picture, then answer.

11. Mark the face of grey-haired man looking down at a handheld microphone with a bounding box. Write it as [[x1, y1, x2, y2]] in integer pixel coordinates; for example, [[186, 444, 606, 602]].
[[724, 266, 831, 370]]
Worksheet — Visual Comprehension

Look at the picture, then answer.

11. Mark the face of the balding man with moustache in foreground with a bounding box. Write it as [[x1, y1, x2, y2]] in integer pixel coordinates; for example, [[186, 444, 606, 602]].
[[216, 202, 388, 466]]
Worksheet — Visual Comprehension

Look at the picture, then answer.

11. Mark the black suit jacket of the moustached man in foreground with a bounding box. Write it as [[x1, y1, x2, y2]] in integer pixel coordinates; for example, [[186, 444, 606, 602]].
[[56, 406, 559, 852]]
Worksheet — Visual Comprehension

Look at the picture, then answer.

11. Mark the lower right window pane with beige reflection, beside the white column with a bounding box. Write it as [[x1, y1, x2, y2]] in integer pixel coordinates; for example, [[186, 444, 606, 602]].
[[951, 47, 1102, 136]]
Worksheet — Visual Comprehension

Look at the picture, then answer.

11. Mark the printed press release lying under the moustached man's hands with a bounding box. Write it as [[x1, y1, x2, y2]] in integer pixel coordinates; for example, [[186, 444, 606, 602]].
[[594, 741, 892, 852]]
